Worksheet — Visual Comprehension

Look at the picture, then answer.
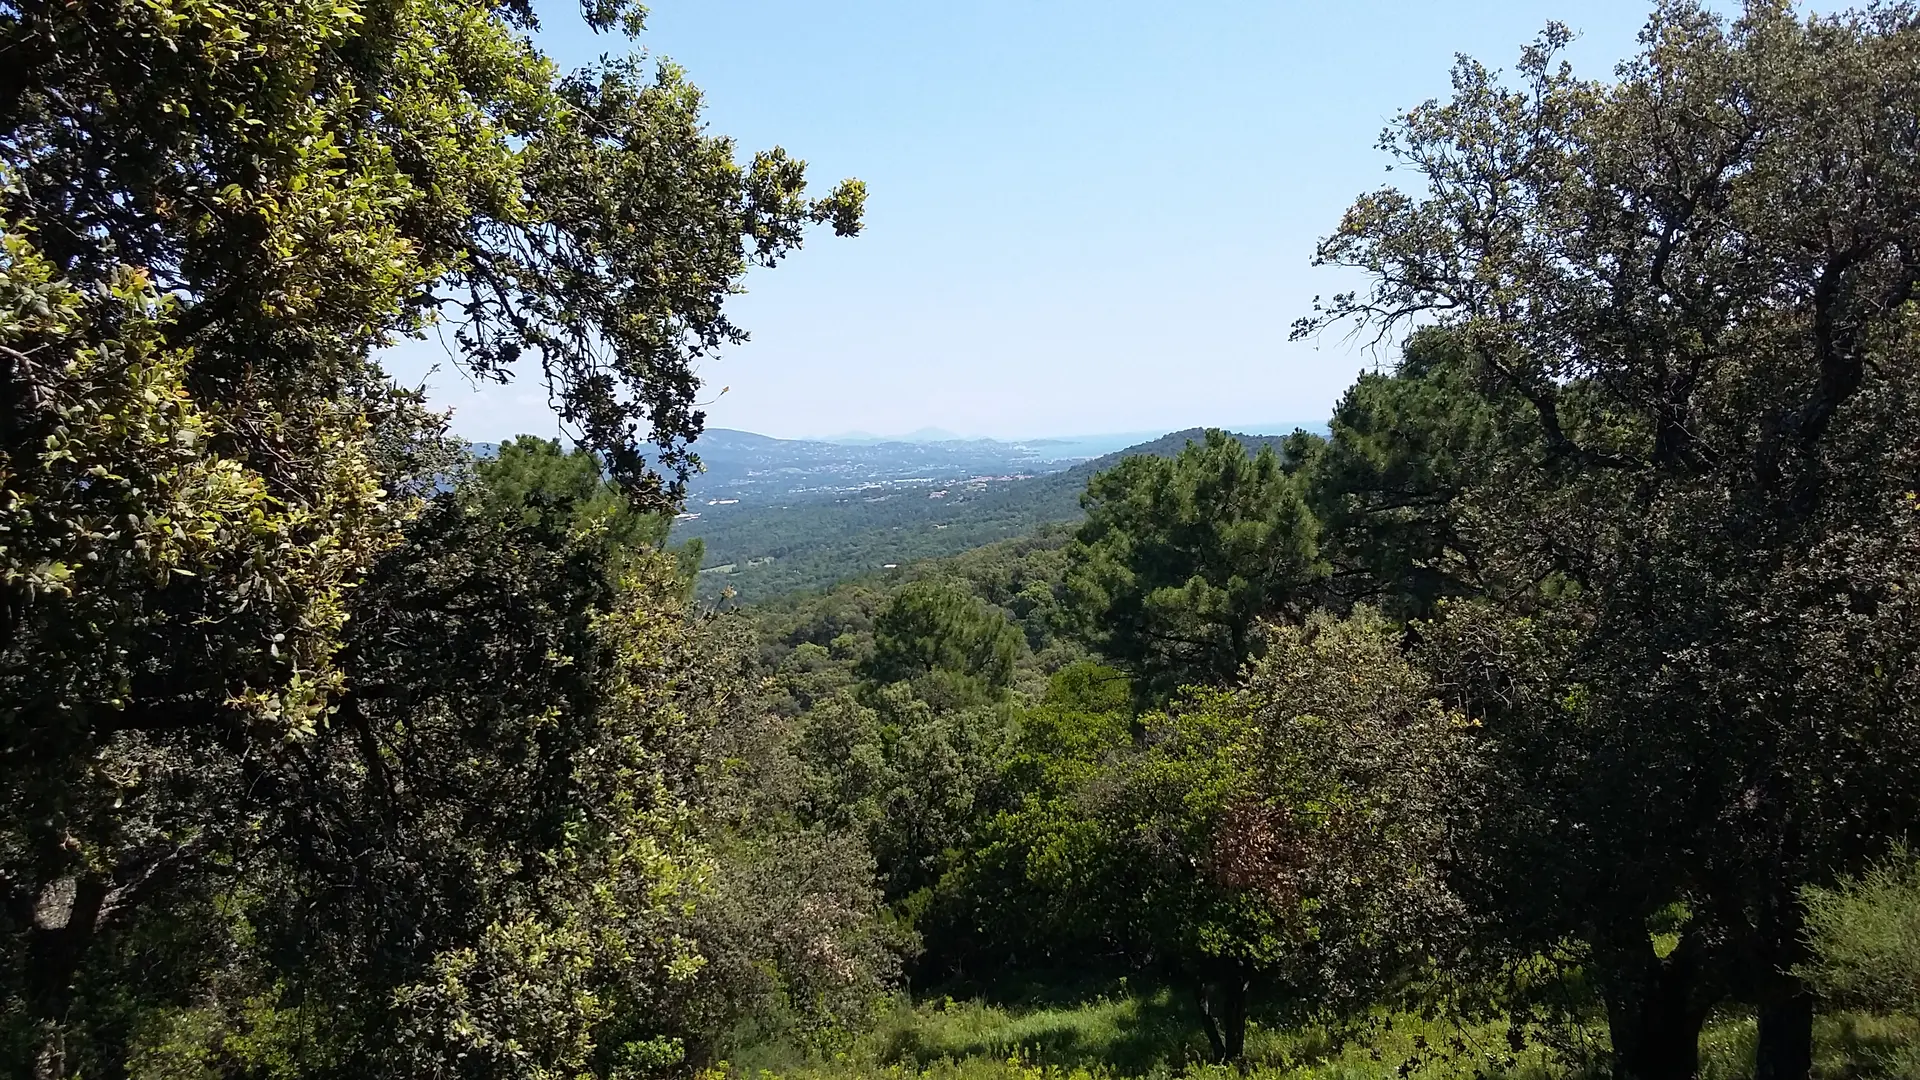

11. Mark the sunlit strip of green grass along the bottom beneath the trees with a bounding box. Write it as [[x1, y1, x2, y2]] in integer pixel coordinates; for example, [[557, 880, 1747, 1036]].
[[724, 990, 1920, 1080]]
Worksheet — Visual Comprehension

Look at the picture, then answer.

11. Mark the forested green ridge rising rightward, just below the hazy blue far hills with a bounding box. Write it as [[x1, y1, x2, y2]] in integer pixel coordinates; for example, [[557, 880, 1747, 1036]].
[[674, 427, 1320, 603]]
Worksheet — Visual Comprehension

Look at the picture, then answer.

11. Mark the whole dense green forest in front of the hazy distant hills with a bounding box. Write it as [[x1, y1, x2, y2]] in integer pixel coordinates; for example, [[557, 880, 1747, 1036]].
[[0, 0, 1920, 1080]]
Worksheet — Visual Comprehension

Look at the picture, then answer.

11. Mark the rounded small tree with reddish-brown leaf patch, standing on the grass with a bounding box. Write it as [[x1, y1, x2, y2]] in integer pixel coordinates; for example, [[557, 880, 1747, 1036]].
[[1087, 611, 1461, 1059]]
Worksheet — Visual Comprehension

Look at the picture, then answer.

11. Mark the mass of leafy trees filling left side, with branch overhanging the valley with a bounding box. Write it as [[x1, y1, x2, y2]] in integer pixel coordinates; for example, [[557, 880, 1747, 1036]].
[[0, 0, 862, 1076]]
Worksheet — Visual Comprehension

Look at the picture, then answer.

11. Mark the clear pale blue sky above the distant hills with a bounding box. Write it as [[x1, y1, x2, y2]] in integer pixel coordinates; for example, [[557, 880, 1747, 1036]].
[[386, 0, 1681, 440]]
